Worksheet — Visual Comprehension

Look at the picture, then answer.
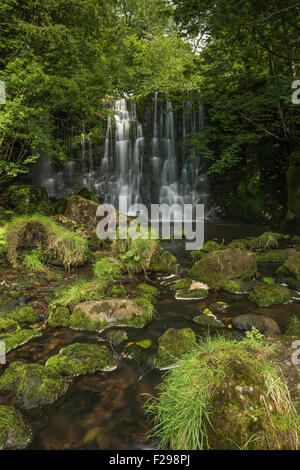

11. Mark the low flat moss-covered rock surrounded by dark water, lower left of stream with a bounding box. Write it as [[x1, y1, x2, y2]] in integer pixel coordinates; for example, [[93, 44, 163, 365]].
[[46, 343, 117, 376]]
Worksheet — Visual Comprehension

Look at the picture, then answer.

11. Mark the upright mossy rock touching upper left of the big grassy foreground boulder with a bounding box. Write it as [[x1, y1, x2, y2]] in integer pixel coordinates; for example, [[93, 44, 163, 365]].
[[156, 328, 196, 369]]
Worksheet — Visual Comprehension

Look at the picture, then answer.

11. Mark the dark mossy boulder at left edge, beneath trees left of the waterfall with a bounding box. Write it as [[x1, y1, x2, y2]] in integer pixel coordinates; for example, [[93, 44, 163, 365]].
[[2, 183, 52, 215]]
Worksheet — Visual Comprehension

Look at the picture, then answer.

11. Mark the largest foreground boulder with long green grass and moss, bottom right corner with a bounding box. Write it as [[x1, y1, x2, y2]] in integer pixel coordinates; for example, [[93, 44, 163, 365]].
[[146, 336, 300, 450]]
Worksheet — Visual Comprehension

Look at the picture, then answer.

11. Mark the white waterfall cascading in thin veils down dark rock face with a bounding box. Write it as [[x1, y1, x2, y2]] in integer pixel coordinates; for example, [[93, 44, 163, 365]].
[[29, 93, 208, 218]]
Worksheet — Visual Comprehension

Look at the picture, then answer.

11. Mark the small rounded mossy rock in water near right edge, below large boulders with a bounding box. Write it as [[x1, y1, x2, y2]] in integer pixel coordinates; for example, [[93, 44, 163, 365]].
[[249, 283, 291, 307]]
